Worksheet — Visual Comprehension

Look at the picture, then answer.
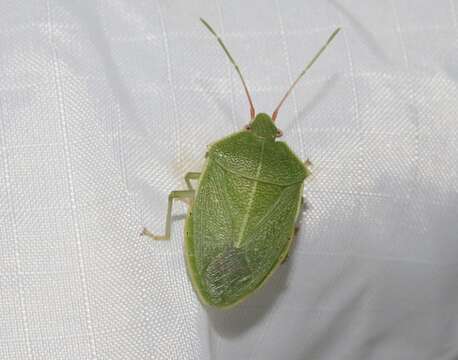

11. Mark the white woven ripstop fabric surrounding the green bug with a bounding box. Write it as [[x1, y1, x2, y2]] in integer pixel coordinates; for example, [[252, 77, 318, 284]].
[[0, 0, 458, 360]]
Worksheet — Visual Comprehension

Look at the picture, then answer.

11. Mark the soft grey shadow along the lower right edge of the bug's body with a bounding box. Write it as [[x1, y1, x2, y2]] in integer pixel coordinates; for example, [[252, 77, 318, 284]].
[[207, 199, 309, 338]]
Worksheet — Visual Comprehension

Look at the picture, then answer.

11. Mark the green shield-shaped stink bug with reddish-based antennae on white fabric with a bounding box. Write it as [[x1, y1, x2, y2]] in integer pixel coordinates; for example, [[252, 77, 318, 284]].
[[143, 19, 340, 308]]
